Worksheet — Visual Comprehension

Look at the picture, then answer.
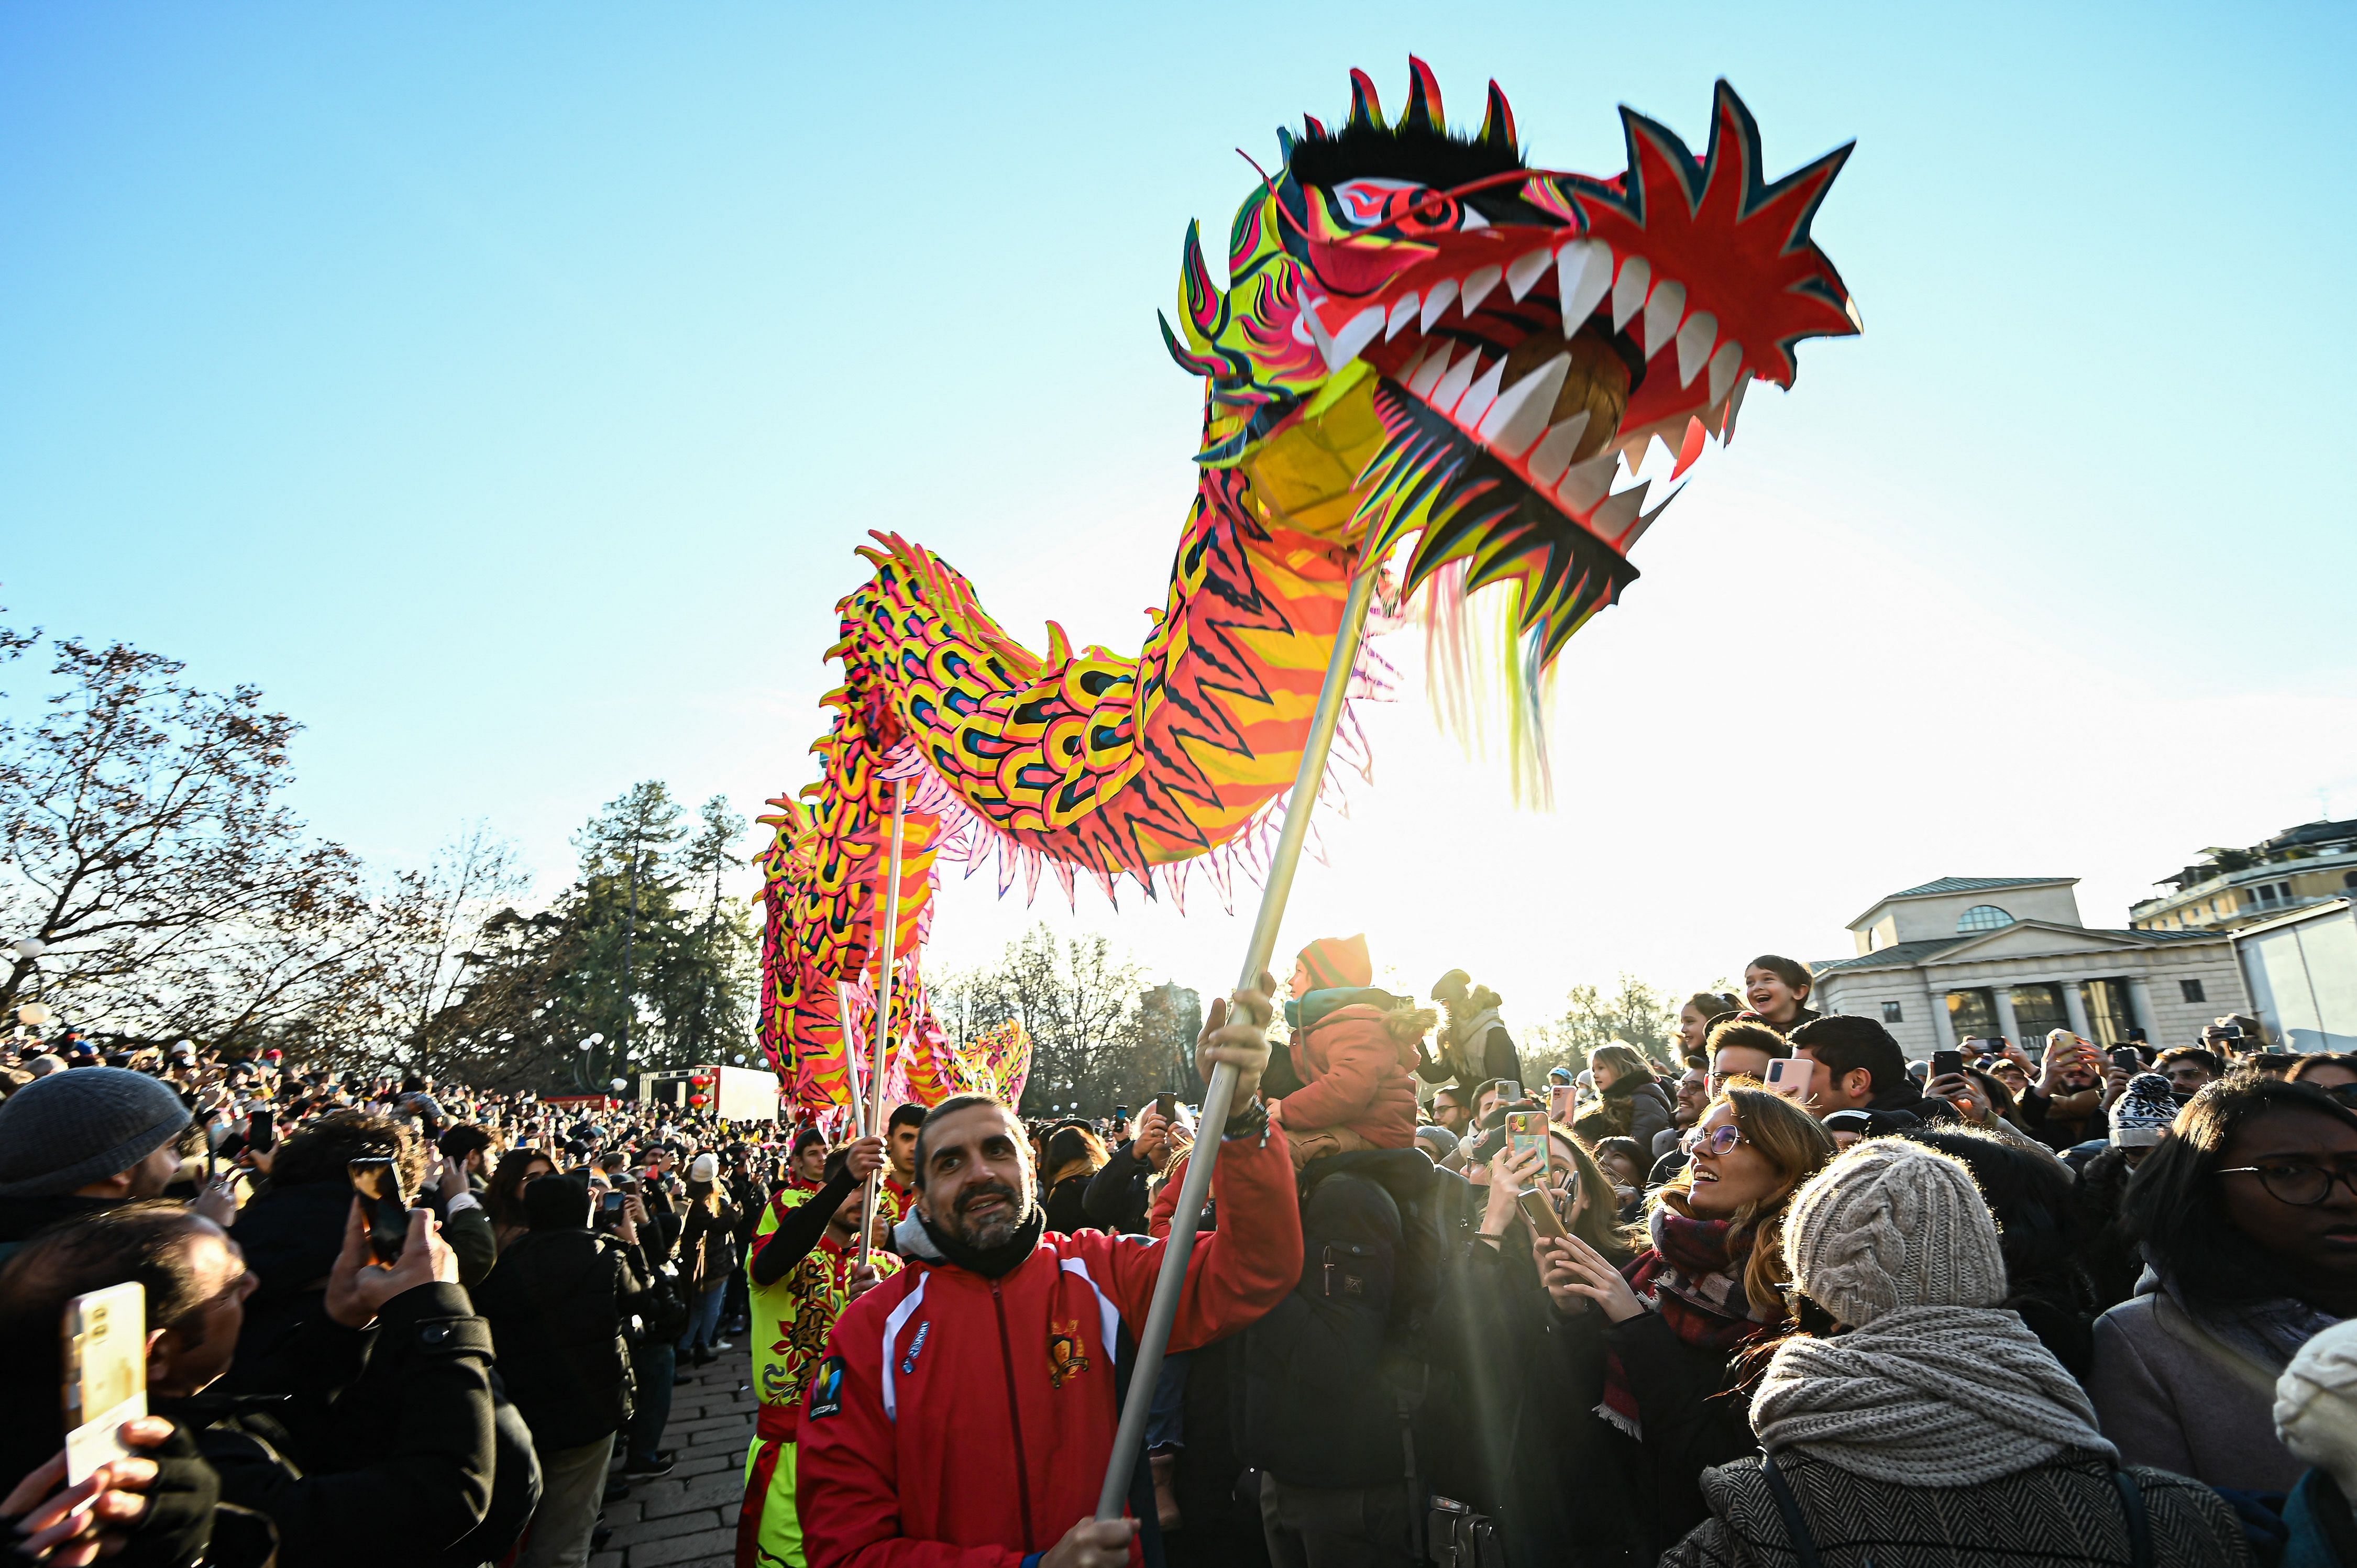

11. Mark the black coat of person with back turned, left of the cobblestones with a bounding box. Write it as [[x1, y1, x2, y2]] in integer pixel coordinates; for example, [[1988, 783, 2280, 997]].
[[476, 1226, 651, 1448]]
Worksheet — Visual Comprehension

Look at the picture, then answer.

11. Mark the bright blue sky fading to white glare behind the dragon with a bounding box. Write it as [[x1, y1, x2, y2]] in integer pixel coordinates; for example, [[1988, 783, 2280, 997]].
[[0, 3, 2357, 1023]]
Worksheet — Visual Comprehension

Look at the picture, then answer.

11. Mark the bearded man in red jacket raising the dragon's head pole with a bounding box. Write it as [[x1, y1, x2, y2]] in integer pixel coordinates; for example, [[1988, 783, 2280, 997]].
[[799, 976, 1301, 1568]]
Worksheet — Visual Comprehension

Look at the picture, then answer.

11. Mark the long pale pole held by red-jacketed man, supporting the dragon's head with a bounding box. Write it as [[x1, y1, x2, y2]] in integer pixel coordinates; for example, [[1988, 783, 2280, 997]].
[[1096, 561, 1376, 1518]]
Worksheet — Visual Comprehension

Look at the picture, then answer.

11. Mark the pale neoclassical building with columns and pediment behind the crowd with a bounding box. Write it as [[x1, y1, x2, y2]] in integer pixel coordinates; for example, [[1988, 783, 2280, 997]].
[[1813, 877, 2251, 1059]]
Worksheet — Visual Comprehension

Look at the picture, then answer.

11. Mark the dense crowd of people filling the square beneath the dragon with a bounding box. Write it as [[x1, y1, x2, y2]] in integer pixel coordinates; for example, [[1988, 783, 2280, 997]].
[[14, 938, 2357, 1568]]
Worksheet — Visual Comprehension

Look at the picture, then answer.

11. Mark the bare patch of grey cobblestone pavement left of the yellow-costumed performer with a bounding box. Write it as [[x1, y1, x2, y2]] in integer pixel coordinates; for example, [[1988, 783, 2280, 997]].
[[589, 1334, 754, 1568]]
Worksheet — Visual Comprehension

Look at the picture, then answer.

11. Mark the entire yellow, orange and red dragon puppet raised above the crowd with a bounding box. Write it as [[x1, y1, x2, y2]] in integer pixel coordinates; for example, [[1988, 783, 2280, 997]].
[[762, 59, 1860, 1108]]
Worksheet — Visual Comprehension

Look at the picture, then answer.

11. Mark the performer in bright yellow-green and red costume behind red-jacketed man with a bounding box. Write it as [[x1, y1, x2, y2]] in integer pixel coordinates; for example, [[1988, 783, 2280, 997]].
[[735, 1139, 900, 1568]]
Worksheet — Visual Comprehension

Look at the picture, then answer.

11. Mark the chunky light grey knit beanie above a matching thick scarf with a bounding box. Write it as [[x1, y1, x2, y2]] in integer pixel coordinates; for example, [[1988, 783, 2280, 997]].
[[1785, 1136, 2006, 1328]]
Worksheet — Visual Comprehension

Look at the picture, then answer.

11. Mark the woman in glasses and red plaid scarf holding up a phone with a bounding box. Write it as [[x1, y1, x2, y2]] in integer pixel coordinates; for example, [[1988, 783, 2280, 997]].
[[1539, 1087, 1834, 1551]]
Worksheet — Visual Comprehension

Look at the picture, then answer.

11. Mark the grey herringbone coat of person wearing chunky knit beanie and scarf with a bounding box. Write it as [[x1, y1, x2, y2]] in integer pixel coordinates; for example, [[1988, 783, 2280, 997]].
[[1662, 1452, 2253, 1568]]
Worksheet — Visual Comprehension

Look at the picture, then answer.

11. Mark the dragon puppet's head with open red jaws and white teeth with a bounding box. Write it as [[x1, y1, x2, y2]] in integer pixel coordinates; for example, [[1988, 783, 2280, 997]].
[[1162, 59, 1860, 675]]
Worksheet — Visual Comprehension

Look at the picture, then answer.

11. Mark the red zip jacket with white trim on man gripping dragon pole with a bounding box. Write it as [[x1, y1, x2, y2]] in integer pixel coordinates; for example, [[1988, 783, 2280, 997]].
[[797, 1127, 1301, 1568]]
